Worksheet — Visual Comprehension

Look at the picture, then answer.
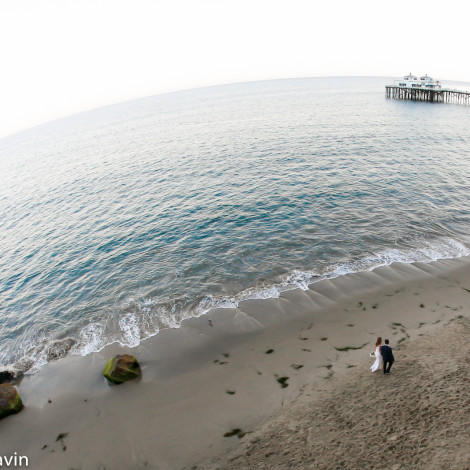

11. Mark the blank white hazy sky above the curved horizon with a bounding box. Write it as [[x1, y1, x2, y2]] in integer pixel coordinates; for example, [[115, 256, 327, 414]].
[[0, 0, 470, 137]]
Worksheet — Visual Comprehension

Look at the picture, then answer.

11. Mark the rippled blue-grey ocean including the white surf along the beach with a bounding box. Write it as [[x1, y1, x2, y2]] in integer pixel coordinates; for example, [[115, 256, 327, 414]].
[[0, 78, 470, 373]]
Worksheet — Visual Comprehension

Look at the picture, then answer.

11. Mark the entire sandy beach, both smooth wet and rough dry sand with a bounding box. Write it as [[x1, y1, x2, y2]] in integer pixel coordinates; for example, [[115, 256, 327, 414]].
[[0, 258, 470, 470]]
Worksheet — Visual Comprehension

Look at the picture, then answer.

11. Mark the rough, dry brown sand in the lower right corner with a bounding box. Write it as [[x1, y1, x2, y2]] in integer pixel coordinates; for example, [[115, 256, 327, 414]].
[[205, 319, 470, 470]]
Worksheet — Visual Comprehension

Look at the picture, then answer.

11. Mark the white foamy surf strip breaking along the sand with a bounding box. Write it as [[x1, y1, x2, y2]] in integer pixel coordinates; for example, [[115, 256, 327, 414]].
[[4, 240, 470, 380]]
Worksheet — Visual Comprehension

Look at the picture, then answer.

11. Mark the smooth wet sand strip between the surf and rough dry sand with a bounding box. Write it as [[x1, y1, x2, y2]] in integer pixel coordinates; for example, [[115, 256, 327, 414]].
[[0, 257, 470, 469]]
